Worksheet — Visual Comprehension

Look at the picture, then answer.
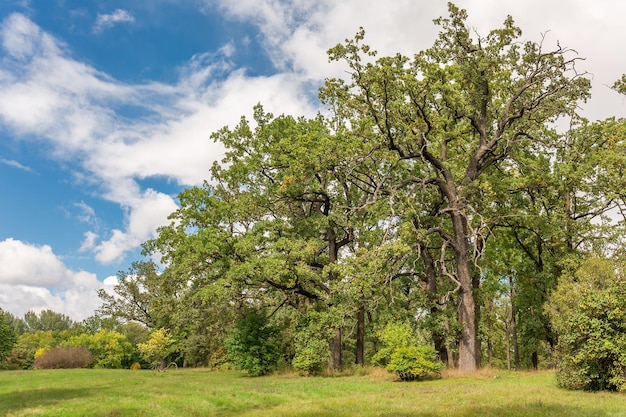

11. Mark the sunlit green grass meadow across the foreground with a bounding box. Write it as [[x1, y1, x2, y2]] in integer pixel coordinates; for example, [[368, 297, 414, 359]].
[[0, 369, 626, 417]]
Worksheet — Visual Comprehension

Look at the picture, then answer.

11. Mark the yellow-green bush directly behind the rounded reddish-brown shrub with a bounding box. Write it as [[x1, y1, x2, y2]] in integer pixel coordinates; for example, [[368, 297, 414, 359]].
[[64, 330, 133, 368]]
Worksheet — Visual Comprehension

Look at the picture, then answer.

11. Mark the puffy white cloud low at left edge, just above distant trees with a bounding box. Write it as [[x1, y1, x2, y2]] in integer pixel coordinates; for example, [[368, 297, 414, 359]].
[[0, 238, 109, 320]]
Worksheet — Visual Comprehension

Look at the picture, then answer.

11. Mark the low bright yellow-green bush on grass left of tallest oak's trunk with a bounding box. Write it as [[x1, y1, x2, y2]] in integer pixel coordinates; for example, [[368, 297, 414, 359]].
[[386, 346, 444, 381]]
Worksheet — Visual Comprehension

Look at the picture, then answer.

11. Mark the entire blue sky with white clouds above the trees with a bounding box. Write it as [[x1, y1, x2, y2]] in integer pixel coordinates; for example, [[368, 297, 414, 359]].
[[0, 0, 626, 321]]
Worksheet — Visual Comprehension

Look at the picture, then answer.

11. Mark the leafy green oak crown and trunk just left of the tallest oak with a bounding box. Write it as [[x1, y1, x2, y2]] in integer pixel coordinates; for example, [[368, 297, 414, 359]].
[[212, 106, 385, 369]]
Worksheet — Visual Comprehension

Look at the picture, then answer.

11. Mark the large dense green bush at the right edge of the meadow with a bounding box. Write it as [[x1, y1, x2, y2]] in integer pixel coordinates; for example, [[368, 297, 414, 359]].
[[552, 260, 626, 391]]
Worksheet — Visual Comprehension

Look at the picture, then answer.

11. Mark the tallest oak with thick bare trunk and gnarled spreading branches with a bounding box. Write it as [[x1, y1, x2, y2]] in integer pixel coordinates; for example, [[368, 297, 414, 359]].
[[323, 4, 589, 370]]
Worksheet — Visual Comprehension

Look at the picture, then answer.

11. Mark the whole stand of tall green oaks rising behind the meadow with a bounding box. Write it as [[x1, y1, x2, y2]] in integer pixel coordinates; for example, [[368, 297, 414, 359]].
[[1, 4, 626, 386]]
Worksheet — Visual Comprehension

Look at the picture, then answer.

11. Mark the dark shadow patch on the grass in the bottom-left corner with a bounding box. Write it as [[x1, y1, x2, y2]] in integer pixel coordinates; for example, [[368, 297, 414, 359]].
[[0, 388, 93, 415]]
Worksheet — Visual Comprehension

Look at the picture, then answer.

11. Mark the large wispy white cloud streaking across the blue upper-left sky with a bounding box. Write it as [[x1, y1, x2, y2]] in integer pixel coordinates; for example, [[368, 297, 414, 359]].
[[0, 14, 315, 263]]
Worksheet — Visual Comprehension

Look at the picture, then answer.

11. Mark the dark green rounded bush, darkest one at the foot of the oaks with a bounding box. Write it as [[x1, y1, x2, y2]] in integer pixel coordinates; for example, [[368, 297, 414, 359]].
[[226, 308, 280, 376]]
